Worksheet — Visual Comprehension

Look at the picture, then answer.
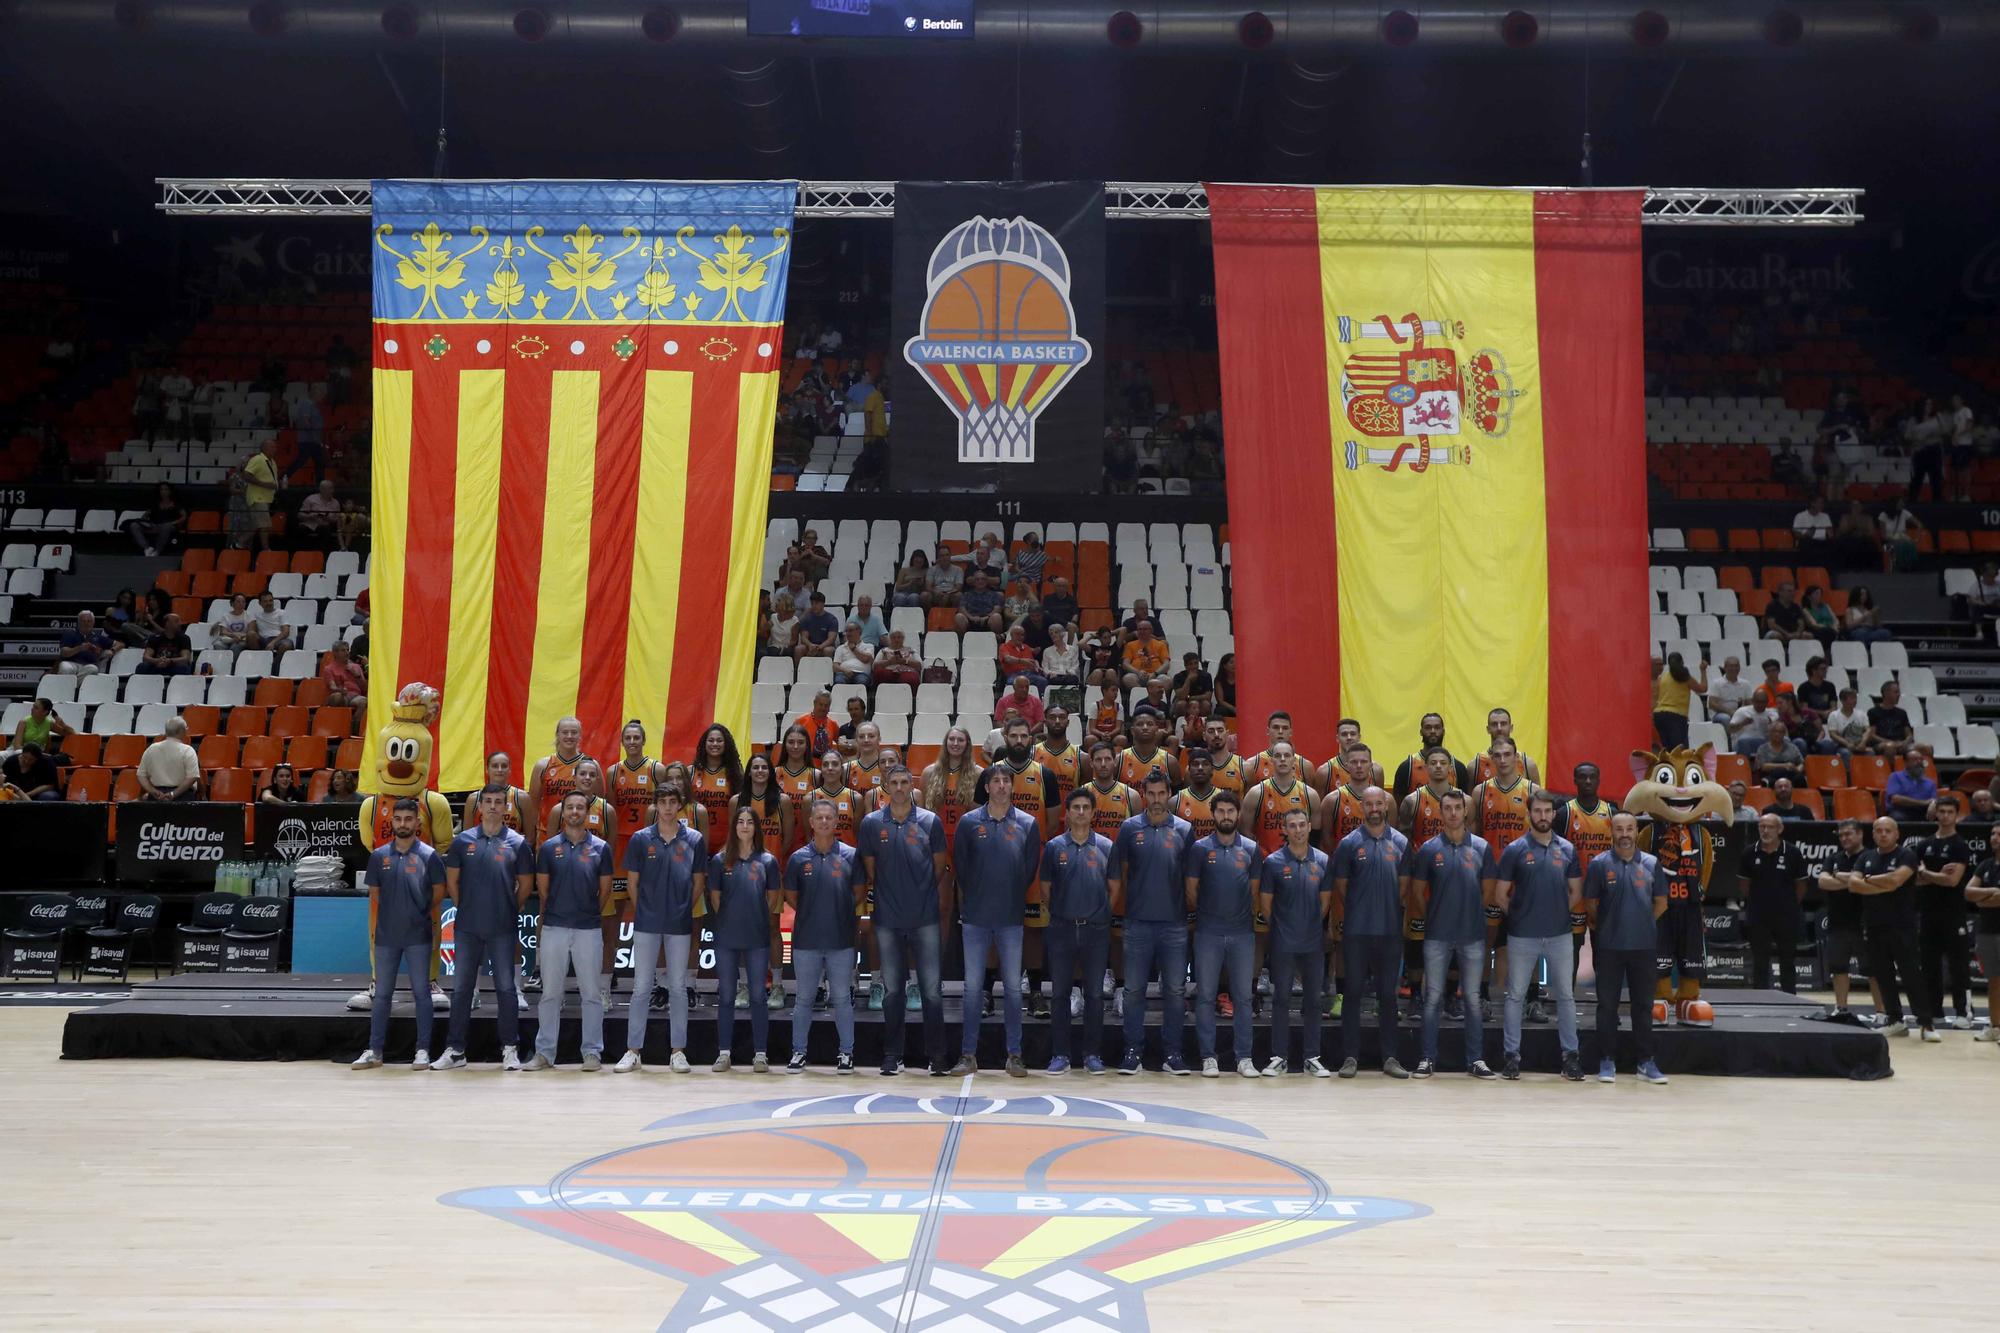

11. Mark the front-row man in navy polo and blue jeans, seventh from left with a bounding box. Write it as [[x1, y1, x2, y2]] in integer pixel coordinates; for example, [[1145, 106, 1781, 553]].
[[856, 765, 952, 1079]]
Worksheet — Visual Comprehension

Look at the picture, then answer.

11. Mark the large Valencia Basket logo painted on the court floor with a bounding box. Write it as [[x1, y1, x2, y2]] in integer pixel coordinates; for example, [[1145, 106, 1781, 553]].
[[442, 1095, 1430, 1333]]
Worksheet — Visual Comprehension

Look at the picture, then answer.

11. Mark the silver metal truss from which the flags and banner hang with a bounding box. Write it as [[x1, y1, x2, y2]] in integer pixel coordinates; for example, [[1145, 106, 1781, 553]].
[[156, 178, 1862, 226]]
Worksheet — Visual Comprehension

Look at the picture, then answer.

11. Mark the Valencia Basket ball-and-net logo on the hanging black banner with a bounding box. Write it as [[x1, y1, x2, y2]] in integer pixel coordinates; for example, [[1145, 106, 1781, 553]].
[[902, 218, 1090, 462]]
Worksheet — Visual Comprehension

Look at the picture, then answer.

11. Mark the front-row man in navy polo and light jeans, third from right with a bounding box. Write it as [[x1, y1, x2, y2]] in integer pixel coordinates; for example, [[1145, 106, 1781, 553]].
[[1402, 791, 1496, 1079]]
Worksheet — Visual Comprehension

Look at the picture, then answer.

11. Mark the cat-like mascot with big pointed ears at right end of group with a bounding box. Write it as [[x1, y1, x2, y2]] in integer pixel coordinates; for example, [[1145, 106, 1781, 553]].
[[1624, 745, 1734, 1027]]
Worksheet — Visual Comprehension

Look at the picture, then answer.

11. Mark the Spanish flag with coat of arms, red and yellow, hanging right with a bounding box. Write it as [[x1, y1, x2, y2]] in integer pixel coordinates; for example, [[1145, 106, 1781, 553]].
[[1208, 186, 1652, 791]]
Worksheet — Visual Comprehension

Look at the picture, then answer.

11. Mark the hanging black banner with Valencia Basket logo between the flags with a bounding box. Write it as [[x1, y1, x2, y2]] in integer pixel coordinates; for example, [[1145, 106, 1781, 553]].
[[896, 182, 1104, 494]]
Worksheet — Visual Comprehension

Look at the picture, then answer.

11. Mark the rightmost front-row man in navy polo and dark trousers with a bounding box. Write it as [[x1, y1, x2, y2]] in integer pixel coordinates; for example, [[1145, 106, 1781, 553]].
[[1584, 813, 1666, 1083]]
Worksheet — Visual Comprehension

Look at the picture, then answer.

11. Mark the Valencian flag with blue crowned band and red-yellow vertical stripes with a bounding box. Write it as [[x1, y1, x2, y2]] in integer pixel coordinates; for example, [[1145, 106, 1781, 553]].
[[362, 180, 796, 791]]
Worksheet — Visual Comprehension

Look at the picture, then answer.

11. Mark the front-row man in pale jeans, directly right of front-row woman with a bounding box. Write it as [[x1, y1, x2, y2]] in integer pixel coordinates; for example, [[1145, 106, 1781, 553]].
[[784, 792, 868, 1073]]
